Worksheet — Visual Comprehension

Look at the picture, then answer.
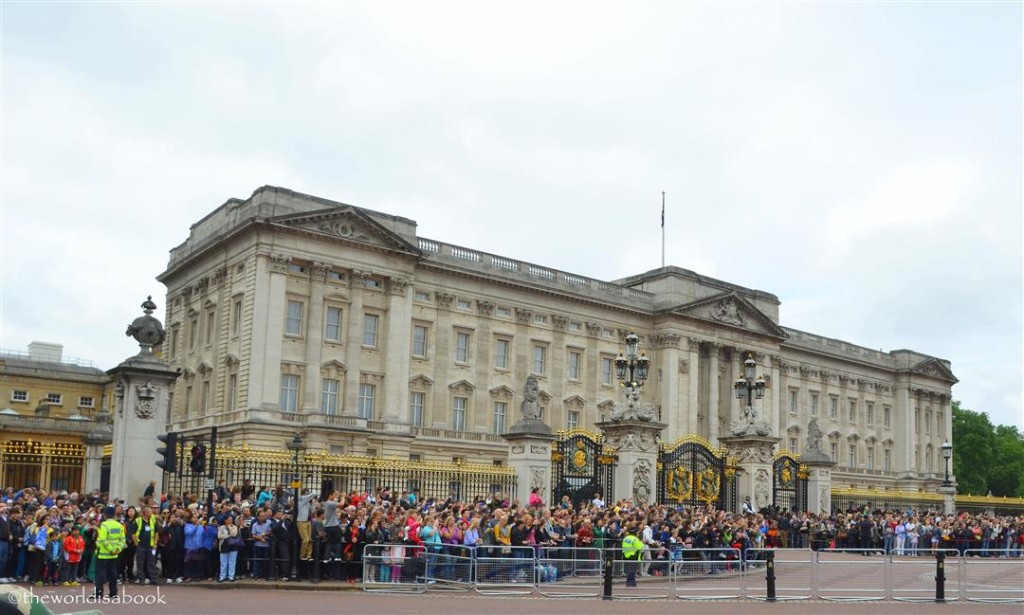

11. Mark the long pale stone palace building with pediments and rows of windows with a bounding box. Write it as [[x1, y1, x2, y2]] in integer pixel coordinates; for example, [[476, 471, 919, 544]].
[[159, 186, 956, 491]]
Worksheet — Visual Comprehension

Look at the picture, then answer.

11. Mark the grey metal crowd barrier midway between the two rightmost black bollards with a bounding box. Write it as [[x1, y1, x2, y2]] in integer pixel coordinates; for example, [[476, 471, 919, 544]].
[[815, 548, 890, 602]]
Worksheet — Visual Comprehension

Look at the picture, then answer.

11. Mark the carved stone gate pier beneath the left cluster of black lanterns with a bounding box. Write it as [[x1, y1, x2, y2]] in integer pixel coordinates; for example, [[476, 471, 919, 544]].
[[597, 419, 666, 504]]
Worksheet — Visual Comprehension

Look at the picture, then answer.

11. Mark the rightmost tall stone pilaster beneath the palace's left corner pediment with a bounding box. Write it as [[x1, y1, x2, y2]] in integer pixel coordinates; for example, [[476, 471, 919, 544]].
[[382, 277, 413, 421]]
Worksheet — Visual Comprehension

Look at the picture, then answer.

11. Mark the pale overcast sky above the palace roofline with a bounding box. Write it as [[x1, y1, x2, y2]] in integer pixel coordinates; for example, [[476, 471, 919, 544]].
[[0, 1, 1024, 426]]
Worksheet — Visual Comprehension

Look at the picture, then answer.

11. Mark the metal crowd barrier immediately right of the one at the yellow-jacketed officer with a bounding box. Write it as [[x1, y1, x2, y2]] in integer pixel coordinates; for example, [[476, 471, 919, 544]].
[[669, 547, 746, 600]]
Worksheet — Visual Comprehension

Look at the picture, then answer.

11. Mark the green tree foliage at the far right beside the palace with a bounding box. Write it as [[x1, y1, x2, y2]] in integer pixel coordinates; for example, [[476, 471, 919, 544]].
[[952, 401, 1024, 497]]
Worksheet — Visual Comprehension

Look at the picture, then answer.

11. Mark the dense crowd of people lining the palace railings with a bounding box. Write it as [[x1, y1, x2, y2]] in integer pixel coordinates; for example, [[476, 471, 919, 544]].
[[0, 481, 1024, 596]]
